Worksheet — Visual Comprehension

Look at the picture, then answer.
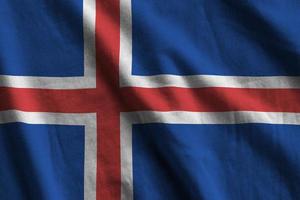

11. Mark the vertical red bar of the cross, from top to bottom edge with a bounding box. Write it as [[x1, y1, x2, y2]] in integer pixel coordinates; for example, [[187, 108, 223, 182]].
[[96, 0, 121, 200]]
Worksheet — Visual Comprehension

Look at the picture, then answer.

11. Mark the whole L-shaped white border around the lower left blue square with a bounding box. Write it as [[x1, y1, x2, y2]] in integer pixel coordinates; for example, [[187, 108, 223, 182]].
[[0, 110, 97, 200]]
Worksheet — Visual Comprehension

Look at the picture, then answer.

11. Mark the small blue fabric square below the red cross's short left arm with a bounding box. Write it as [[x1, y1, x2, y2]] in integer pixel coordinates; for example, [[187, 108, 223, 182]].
[[0, 123, 84, 200]]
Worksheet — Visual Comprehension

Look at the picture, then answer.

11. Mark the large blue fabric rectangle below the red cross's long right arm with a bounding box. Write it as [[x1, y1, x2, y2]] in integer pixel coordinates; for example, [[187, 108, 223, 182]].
[[133, 124, 300, 200]]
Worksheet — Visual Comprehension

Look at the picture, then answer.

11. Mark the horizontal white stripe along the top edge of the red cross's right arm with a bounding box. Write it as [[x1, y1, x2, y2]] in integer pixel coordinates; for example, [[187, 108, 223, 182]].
[[120, 74, 300, 88]]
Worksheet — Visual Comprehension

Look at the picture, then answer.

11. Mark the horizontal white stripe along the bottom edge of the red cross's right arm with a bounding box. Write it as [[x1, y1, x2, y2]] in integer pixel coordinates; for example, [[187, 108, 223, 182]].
[[122, 111, 300, 125]]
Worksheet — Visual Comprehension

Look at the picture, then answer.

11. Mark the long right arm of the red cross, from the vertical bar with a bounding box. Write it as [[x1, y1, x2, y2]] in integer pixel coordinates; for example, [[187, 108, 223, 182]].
[[121, 87, 300, 112]]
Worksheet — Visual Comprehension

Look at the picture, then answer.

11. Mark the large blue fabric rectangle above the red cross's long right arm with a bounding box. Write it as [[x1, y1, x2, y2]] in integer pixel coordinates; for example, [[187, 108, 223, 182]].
[[132, 0, 300, 76]]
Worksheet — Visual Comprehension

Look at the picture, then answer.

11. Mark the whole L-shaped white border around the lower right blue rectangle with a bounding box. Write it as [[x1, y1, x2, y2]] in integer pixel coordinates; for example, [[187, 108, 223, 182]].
[[121, 111, 300, 200]]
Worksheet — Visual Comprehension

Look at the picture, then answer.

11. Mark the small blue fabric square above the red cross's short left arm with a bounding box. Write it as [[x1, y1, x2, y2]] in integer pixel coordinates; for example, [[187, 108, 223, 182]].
[[0, 0, 84, 77]]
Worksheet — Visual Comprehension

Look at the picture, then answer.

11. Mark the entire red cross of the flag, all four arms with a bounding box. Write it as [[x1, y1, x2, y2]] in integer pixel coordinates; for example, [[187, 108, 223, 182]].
[[0, 0, 300, 200]]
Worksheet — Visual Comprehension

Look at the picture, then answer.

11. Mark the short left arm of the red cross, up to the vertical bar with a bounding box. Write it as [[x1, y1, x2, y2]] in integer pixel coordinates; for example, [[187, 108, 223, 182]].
[[0, 88, 97, 113]]
